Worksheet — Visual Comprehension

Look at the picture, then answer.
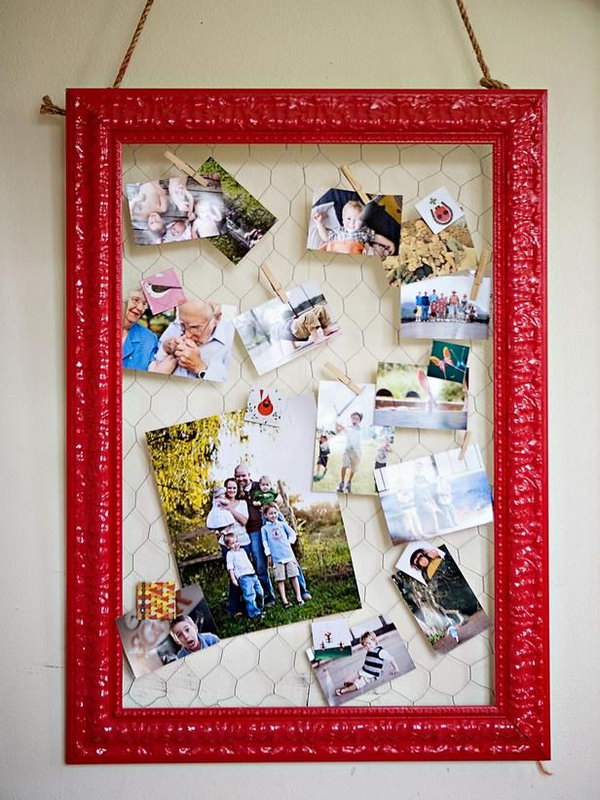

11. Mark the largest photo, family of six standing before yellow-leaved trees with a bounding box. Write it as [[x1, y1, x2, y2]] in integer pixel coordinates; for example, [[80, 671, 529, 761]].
[[146, 395, 361, 637]]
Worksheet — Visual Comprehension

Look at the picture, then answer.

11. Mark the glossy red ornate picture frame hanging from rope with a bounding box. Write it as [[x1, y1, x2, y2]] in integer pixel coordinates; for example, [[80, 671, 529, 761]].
[[66, 89, 550, 763]]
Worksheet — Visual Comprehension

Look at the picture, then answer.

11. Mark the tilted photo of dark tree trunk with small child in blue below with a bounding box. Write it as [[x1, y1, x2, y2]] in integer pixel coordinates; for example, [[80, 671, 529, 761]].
[[392, 542, 490, 654]]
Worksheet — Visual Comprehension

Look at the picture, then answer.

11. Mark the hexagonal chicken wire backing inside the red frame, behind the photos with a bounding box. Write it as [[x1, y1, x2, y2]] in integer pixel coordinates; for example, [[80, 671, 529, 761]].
[[123, 144, 493, 707]]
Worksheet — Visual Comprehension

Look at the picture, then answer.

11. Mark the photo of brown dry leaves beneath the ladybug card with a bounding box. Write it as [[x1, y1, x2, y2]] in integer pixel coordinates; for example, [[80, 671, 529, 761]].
[[382, 214, 478, 286]]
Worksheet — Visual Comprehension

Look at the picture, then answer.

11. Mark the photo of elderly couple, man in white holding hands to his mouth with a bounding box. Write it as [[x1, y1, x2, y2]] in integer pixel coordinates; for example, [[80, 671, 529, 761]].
[[121, 288, 236, 382]]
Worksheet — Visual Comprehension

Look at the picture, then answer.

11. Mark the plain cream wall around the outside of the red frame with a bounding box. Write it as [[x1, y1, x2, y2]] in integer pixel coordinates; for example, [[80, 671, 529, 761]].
[[0, 0, 600, 800]]
